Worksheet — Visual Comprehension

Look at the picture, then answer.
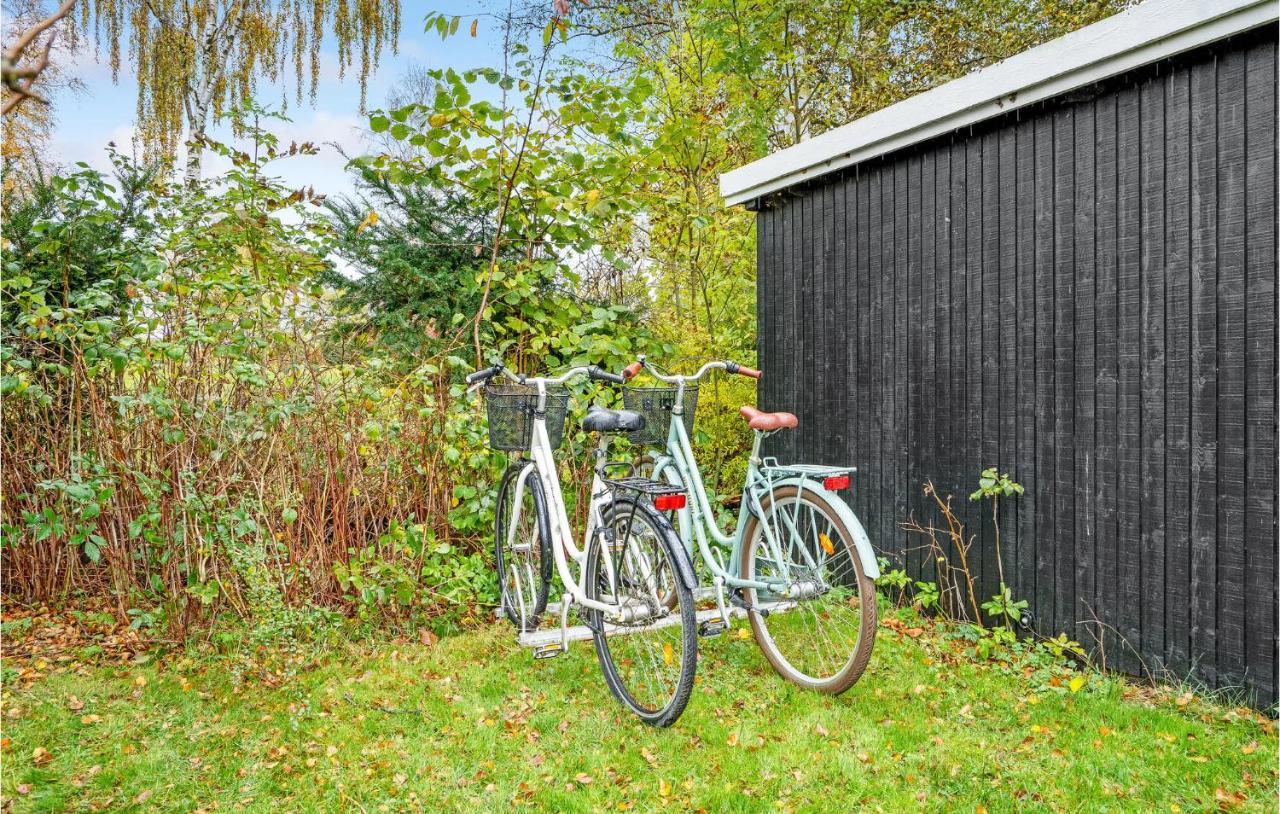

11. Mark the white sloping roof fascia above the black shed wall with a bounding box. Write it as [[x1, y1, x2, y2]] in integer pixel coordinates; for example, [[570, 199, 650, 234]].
[[719, 0, 1280, 205]]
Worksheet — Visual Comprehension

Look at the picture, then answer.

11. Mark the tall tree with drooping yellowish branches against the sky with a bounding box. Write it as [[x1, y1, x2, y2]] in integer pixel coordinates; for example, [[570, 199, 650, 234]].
[[79, 0, 401, 180]]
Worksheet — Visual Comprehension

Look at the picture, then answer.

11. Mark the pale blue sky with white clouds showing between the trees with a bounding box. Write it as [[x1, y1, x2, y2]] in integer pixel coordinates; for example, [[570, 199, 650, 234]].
[[50, 7, 524, 203]]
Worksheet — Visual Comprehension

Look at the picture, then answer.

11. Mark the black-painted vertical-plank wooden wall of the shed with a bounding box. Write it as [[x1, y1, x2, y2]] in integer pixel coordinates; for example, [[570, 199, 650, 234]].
[[758, 26, 1277, 704]]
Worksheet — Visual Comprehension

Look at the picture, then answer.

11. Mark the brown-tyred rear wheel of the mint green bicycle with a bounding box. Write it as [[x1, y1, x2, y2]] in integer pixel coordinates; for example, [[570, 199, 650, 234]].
[[740, 486, 876, 695]]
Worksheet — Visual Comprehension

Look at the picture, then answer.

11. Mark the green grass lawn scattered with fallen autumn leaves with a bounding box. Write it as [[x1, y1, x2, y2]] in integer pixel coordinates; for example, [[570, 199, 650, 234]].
[[3, 612, 1277, 813]]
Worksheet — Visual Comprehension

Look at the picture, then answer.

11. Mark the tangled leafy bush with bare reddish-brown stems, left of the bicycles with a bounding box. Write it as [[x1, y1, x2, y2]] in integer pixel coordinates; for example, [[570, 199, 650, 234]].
[[0, 111, 494, 637]]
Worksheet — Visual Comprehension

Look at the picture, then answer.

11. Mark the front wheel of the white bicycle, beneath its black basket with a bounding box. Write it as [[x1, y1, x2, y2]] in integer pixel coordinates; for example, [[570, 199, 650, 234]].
[[494, 461, 552, 631]]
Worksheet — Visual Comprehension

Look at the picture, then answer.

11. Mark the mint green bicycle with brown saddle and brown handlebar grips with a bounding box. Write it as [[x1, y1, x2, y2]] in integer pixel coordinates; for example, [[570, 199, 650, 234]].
[[623, 356, 879, 695]]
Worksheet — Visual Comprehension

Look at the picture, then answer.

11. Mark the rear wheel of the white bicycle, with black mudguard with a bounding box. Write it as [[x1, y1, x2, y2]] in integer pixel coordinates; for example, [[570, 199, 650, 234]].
[[586, 497, 698, 727]]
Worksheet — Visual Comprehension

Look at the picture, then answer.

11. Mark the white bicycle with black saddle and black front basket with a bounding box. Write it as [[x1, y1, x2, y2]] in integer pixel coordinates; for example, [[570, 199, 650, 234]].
[[467, 365, 698, 727]]
